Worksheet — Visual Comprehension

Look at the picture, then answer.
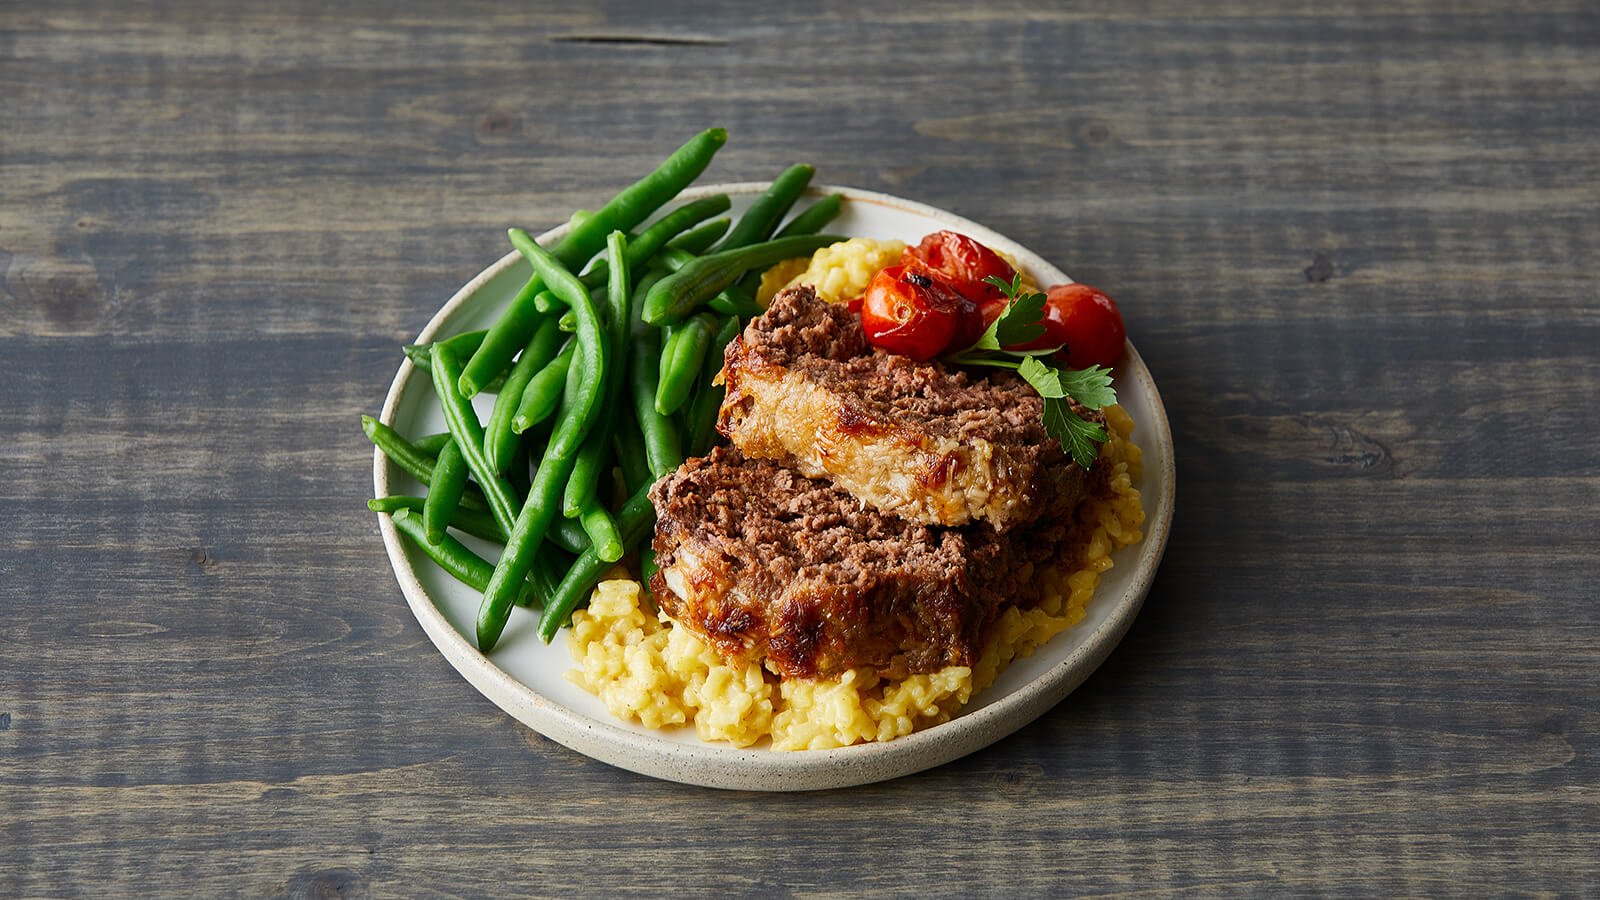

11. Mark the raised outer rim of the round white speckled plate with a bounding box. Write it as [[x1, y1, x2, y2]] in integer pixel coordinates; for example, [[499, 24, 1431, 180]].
[[373, 181, 1176, 791]]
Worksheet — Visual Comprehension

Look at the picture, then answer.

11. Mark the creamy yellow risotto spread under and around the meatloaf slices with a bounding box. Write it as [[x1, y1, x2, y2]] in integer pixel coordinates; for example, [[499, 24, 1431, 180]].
[[566, 239, 1144, 749]]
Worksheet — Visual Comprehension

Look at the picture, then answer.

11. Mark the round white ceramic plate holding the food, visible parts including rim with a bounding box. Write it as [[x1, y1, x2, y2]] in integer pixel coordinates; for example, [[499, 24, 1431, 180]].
[[373, 184, 1174, 791]]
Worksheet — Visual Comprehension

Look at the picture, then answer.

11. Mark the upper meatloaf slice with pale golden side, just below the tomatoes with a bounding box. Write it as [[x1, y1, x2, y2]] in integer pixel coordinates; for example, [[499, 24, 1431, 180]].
[[717, 285, 1104, 532]]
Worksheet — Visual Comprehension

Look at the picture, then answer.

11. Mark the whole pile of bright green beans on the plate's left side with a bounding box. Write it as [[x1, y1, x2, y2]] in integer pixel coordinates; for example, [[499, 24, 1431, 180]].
[[362, 128, 842, 653]]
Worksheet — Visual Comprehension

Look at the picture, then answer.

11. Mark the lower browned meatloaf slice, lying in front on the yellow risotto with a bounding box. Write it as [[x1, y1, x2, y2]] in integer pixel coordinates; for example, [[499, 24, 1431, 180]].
[[650, 447, 1088, 677]]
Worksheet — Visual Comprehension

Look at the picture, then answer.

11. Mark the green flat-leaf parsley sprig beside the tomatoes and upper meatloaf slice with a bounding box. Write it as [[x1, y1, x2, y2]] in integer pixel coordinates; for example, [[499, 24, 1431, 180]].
[[944, 272, 1117, 469]]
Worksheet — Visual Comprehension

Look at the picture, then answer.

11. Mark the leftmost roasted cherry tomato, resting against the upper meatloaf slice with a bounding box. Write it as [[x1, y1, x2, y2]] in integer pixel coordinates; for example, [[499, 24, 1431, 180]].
[[861, 266, 962, 360]]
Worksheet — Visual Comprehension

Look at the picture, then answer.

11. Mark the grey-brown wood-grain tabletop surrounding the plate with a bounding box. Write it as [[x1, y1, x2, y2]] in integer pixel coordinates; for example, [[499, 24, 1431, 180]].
[[0, 0, 1600, 898]]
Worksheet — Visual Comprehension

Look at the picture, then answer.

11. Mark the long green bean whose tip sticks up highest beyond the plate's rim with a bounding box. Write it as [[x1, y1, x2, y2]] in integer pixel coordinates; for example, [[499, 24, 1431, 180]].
[[461, 128, 728, 397]]
